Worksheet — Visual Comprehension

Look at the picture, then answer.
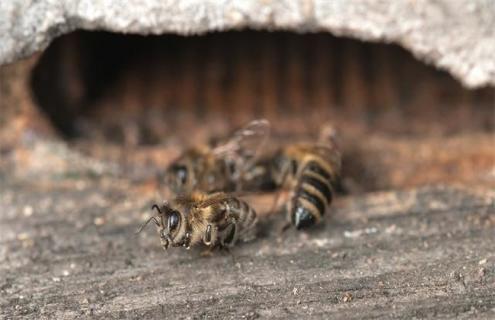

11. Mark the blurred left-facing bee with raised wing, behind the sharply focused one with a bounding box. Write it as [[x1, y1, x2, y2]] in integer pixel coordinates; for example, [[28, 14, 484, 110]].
[[165, 119, 270, 194]]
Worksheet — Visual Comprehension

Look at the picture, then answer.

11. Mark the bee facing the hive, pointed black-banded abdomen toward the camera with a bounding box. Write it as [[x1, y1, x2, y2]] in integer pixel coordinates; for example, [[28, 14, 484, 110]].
[[271, 129, 341, 229]]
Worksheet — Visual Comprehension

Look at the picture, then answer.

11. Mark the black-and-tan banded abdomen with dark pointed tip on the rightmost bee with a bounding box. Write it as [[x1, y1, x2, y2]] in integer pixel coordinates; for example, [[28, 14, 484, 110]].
[[288, 160, 334, 229]]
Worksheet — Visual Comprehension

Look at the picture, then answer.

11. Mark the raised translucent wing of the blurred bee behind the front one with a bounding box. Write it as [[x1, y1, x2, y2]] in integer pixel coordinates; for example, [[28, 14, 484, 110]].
[[213, 119, 270, 170]]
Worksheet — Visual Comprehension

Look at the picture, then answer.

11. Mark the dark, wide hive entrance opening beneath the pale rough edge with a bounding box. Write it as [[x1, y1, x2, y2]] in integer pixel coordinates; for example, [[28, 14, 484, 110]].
[[32, 31, 495, 189]]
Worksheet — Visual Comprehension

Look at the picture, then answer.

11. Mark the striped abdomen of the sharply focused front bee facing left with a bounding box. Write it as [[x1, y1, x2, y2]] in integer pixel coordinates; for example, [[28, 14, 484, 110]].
[[219, 198, 258, 246]]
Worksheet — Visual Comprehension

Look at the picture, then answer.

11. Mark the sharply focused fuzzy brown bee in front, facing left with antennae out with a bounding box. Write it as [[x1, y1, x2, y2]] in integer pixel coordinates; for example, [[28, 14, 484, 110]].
[[138, 192, 257, 250]]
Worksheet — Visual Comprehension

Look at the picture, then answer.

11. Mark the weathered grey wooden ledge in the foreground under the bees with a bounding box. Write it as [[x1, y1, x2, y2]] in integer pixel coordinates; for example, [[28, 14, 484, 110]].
[[0, 170, 495, 319]]
